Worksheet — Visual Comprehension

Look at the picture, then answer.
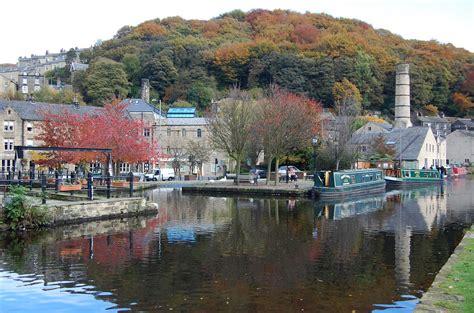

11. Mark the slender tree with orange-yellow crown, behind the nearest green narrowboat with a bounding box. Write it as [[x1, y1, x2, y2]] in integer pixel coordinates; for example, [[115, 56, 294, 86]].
[[327, 78, 362, 170]]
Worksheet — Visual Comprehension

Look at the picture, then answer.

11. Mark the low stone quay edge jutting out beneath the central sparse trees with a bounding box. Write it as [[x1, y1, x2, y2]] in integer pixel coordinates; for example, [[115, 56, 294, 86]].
[[182, 180, 313, 198]]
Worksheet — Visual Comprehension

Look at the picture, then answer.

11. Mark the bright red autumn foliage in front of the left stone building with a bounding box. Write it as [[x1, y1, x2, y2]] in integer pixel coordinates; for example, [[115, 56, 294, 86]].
[[35, 101, 157, 171]]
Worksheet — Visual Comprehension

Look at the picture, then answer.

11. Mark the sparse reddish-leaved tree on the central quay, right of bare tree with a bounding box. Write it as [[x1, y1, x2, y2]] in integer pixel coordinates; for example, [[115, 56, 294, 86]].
[[254, 86, 321, 185]]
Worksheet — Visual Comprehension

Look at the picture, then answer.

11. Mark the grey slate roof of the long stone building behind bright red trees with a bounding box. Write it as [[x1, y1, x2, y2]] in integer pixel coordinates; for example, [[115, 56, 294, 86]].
[[0, 100, 101, 121]]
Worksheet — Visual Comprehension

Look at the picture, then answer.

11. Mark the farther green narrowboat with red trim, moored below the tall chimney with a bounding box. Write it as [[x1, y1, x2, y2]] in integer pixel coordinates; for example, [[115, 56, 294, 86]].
[[384, 169, 443, 187]]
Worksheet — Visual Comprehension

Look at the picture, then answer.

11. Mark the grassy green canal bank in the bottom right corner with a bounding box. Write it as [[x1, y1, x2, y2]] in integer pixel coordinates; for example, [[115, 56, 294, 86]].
[[414, 226, 474, 313]]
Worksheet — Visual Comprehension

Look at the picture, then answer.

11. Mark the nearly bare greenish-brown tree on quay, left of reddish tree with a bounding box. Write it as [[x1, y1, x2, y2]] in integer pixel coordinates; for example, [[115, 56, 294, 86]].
[[206, 88, 255, 185]]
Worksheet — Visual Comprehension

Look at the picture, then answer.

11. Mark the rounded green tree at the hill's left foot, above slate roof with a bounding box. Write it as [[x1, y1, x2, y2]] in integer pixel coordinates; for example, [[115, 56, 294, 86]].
[[85, 58, 129, 105]]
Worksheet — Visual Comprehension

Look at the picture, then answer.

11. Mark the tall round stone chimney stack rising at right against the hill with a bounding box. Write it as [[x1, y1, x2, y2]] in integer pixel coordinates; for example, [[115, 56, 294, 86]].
[[394, 64, 412, 128]]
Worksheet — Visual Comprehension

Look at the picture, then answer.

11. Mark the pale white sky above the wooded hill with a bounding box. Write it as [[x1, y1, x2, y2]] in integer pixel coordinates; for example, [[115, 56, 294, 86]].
[[0, 0, 474, 63]]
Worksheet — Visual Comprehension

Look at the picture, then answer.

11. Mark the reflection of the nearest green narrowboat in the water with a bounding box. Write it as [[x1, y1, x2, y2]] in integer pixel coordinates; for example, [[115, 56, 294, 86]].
[[315, 194, 385, 220]]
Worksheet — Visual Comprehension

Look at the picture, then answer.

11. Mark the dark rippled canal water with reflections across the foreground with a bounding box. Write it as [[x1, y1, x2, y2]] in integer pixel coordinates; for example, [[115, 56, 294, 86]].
[[0, 180, 474, 312]]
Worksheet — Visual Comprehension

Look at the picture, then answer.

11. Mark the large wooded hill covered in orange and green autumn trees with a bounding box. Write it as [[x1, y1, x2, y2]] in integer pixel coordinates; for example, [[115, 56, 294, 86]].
[[74, 10, 474, 115]]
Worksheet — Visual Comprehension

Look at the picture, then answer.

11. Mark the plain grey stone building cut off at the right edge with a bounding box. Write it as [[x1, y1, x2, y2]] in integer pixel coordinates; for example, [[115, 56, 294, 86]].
[[446, 130, 474, 165]]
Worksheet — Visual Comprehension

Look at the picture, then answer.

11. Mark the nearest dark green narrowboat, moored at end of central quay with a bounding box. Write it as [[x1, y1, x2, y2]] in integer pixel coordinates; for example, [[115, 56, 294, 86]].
[[313, 169, 385, 199]]
